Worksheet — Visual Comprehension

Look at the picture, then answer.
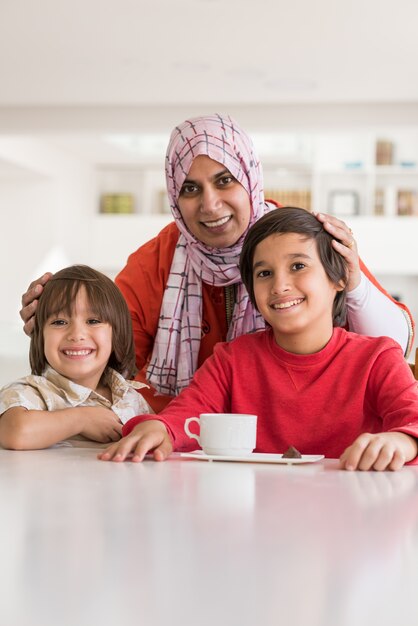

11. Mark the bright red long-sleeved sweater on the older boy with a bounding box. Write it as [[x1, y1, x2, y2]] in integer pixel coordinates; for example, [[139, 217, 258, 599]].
[[123, 328, 418, 458]]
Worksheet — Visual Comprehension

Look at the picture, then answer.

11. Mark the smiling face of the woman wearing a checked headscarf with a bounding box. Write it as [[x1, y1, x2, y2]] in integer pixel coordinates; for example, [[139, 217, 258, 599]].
[[178, 155, 251, 248]]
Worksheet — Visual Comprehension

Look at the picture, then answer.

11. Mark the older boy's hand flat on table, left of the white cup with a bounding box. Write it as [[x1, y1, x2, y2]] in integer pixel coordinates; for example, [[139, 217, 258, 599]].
[[97, 420, 173, 463]]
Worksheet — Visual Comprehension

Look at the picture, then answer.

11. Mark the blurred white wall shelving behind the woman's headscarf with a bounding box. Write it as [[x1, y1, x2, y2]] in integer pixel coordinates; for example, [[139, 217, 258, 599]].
[[93, 128, 418, 219]]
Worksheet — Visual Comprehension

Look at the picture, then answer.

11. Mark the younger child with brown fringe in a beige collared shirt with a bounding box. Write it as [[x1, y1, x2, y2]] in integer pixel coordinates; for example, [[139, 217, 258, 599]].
[[0, 265, 152, 450]]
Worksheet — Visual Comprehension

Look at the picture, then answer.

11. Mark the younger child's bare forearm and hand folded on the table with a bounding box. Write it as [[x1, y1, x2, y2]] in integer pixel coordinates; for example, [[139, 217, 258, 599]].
[[0, 406, 122, 450]]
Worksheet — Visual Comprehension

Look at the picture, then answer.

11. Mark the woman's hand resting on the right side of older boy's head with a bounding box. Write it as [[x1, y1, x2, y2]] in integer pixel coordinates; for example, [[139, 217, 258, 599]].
[[314, 213, 361, 291]]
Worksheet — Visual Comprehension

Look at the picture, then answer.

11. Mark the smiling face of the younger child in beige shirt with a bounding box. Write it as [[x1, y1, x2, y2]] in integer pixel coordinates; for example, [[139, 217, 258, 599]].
[[43, 286, 112, 389]]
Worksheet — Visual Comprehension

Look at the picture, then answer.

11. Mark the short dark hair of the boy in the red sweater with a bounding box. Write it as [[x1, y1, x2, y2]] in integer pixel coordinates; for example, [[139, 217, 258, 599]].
[[240, 207, 348, 326]]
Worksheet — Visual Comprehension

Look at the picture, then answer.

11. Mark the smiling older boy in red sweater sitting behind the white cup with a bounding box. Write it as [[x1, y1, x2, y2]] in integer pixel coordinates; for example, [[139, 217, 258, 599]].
[[99, 207, 418, 470]]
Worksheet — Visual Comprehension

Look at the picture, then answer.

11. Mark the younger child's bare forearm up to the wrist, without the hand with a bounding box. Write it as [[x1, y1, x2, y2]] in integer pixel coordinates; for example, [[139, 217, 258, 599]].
[[0, 407, 83, 450]]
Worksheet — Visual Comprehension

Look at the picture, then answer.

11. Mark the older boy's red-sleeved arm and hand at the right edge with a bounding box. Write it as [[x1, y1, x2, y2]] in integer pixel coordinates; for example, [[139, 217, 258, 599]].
[[340, 346, 418, 471]]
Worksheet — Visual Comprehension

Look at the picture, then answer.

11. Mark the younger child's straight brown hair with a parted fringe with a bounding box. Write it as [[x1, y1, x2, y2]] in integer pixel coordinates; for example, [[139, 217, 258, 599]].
[[29, 265, 136, 378]]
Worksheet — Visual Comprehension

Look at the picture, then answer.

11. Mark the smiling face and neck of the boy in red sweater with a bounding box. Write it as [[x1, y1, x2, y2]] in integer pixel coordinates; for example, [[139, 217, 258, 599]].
[[253, 233, 343, 354]]
